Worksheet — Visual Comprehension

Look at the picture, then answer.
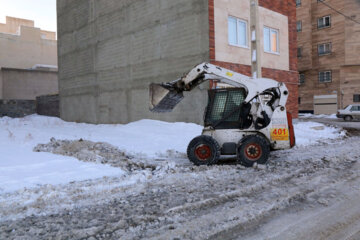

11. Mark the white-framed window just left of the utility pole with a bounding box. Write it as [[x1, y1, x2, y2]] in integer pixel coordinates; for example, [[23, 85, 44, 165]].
[[228, 17, 248, 47]]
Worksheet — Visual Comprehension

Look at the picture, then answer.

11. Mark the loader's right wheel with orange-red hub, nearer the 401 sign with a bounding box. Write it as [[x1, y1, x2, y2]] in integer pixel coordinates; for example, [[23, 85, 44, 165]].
[[237, 135, 270, 167]]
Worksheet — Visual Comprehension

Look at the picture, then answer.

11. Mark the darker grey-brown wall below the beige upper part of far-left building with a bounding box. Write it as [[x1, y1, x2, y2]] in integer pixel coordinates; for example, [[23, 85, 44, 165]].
[[0, 68, 58, 100]]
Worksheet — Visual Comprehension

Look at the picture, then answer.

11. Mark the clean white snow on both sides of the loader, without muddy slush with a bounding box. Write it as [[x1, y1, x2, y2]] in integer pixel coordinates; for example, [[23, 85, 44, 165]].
[[0, 115, 345, 193]]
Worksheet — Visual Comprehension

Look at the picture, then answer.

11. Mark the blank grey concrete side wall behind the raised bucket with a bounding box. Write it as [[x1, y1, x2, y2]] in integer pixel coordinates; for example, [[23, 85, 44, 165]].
[[57, 0, 209, 123]]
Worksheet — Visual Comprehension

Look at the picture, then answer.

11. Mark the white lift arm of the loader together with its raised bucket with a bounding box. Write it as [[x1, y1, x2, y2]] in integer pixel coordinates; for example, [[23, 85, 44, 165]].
[[150, 63, 288, 112]]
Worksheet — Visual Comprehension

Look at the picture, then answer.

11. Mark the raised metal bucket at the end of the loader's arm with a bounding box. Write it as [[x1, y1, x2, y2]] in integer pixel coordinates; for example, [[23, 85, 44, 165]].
[[150, 83, 184, 113]]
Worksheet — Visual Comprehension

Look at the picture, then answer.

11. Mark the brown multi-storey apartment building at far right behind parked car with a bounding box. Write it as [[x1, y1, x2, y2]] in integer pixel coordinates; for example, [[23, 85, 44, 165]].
[[296, 0, 360, 114]]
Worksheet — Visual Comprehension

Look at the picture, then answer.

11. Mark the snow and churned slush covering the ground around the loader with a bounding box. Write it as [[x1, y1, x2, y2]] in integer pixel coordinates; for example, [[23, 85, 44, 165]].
[[0, 115, 360, 240]]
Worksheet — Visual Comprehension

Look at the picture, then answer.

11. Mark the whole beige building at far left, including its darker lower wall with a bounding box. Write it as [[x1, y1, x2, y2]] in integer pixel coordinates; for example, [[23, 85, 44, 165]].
[[0, 17, 58, 100]]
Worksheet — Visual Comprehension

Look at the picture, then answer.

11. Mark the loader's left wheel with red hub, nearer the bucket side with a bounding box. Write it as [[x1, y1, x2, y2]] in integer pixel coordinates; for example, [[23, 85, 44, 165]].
[[187, 135, 220, 166]]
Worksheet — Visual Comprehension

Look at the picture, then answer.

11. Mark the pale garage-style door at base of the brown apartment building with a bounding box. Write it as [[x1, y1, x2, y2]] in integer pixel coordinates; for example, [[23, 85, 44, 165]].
[[314, 95, 338, 114]]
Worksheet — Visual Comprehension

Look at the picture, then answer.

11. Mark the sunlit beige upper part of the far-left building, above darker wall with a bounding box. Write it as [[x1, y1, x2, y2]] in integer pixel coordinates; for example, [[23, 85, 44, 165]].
[[0, 17, 57, 69]]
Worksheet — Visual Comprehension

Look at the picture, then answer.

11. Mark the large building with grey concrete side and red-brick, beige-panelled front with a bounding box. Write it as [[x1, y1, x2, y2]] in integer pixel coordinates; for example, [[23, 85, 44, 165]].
[[57, 0, 298, 123]]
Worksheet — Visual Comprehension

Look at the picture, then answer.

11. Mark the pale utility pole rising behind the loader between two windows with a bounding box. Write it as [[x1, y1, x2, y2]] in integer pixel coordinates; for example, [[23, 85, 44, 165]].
[[250, 0, 262, 78]]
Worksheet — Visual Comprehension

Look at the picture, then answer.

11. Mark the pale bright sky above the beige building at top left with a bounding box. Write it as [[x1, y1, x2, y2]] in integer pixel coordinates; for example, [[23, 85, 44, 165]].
[[0, 0, 56, 32]]
